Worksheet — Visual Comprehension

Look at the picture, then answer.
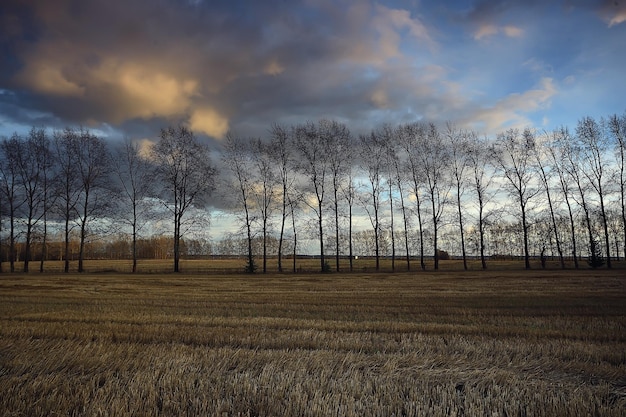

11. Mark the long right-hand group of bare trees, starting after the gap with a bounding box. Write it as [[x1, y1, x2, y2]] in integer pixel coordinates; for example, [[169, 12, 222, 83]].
[[222, 114, 626, 272]]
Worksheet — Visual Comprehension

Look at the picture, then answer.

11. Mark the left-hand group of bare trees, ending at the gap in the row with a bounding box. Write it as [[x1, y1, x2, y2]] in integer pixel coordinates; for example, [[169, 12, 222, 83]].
[[0, 126, 215, 272]]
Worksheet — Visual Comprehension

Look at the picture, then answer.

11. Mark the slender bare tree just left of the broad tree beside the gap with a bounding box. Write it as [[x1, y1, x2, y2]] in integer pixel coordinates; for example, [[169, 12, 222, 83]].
[[114, 139, 154, 273]]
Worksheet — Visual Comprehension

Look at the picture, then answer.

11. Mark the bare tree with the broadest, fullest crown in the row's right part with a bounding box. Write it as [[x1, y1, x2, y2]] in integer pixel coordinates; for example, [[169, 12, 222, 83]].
[[492, 129, 539, 269]]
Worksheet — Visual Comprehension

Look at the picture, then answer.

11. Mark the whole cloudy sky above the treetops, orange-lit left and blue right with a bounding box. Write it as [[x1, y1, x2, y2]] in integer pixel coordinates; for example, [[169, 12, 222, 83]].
[[0, 0, 626, 140]]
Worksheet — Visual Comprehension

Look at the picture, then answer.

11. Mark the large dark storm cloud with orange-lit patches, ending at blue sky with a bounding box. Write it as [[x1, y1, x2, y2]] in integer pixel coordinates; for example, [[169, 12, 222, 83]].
[[2, 0, 444, 137]]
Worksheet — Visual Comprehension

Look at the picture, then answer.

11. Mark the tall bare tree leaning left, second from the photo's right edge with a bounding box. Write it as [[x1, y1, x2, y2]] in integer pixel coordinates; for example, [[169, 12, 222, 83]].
[[576, 117, 611, 268]]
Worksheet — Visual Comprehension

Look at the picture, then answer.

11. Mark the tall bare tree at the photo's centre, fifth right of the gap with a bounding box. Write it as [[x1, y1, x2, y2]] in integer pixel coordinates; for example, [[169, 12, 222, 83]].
[[294, 122, 329, 272]]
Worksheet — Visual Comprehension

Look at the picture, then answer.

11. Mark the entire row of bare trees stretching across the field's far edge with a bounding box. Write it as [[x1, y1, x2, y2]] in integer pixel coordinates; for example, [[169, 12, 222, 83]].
[[0, 114, 626, 272]]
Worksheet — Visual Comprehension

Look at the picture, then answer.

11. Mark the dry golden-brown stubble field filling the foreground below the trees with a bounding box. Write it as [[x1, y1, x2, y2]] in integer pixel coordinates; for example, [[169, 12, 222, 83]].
[[0, 270, 626, 416]]
